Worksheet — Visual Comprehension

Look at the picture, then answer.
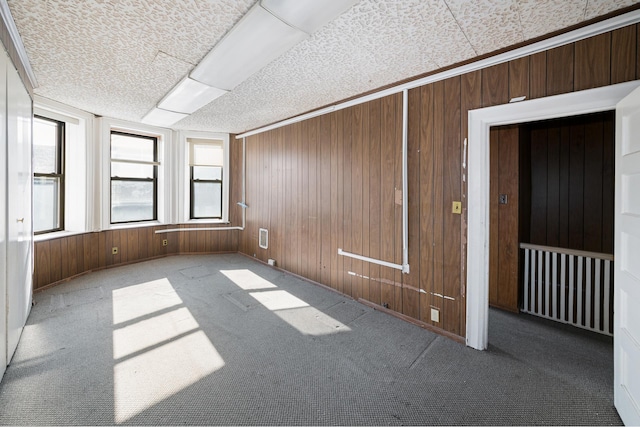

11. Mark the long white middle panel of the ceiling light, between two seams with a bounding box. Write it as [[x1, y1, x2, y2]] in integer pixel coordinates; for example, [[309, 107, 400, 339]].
[[190, 3, 308, 90]]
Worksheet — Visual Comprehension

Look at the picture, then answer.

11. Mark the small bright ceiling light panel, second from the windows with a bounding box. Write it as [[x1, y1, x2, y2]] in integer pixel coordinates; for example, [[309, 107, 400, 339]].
[[158, 77, 228, 114]]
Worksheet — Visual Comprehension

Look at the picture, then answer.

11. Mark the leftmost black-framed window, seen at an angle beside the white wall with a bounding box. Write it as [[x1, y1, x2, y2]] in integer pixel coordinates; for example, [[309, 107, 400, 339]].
[[33, 116, 65, 234]]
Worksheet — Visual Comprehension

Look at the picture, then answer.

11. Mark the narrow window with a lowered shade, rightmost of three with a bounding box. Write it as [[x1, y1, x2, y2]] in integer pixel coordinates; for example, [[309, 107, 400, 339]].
[[187, 139, 224, 219]]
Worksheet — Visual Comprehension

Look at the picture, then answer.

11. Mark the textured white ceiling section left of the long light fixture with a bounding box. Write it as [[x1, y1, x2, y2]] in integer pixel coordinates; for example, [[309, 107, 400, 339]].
[[8, 0, 256, 121]]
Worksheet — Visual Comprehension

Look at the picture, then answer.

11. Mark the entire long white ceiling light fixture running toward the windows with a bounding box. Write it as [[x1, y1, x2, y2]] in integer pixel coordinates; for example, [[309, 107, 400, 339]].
[[142, 0, 358, 127]]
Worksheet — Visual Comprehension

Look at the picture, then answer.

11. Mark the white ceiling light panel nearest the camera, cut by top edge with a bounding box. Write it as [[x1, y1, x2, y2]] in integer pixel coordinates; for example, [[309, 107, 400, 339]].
[[260, 0, 357, 34]]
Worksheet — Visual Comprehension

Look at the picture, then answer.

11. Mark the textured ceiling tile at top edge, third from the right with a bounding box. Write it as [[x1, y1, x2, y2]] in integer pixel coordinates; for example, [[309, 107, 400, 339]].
[[445, 0, 524, 55]]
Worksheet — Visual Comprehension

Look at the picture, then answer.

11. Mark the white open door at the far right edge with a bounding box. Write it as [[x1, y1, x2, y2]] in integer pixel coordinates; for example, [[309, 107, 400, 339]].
[[613, 88, 640, 425]]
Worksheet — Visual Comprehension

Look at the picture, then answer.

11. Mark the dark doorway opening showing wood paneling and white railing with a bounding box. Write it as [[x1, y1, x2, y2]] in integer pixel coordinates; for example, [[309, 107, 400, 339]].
[[489, 111, 615, 335]]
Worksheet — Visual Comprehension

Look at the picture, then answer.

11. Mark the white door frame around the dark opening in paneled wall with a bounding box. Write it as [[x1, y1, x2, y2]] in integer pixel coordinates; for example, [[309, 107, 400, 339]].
[[466, 80, 640, 350]]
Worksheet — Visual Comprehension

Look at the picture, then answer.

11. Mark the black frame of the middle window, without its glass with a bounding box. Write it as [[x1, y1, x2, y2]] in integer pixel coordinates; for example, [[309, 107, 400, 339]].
[[109, 129, 160, 226]]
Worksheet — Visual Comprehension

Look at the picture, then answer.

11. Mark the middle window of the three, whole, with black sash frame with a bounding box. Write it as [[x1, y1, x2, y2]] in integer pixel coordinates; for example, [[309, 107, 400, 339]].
[[111, 131, 159, 224]]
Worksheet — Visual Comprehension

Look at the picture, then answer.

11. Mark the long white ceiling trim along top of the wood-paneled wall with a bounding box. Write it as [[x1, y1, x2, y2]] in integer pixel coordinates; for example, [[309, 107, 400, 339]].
[[236, 10, 640, 139]]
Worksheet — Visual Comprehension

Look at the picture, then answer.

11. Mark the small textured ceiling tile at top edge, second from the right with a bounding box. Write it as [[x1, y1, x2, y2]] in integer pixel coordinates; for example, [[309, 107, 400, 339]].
[[518, 0, 592, 39]]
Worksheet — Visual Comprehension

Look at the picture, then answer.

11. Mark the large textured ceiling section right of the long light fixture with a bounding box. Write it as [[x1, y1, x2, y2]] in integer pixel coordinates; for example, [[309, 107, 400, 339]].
[[177, 0, 475, 132]]
